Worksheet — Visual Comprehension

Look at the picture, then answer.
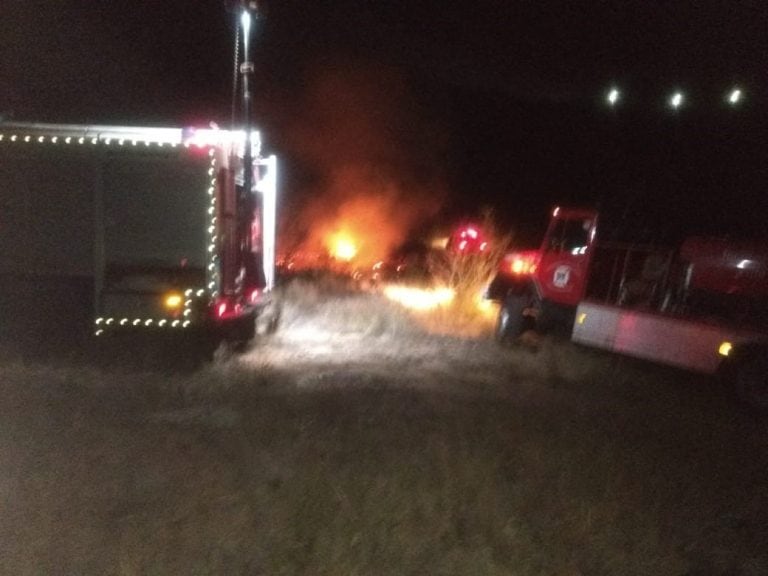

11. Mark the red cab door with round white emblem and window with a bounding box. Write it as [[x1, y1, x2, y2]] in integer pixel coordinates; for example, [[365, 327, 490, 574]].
[[536, 209, 597, 306]]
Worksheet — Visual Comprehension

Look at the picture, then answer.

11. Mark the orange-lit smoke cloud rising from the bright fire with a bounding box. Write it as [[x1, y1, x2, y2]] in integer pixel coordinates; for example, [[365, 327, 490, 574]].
[[281, 62, 445, 265]]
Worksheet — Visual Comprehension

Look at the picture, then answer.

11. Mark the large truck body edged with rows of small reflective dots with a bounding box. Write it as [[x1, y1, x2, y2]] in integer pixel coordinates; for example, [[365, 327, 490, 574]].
[[0, 124, 276, 352]]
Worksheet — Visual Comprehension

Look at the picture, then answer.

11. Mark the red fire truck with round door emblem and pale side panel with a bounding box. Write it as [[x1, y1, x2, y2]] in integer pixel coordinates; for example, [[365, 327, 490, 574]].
[[487, 208, 768, 408]]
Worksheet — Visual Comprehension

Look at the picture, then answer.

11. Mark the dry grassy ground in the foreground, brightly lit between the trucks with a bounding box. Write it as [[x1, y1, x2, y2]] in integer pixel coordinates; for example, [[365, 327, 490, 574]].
[[0, 280, 768, 576]]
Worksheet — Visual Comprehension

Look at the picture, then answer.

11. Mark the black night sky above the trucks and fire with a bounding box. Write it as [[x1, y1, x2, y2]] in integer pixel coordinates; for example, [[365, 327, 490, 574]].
[[0, 0, 768, 245]]
